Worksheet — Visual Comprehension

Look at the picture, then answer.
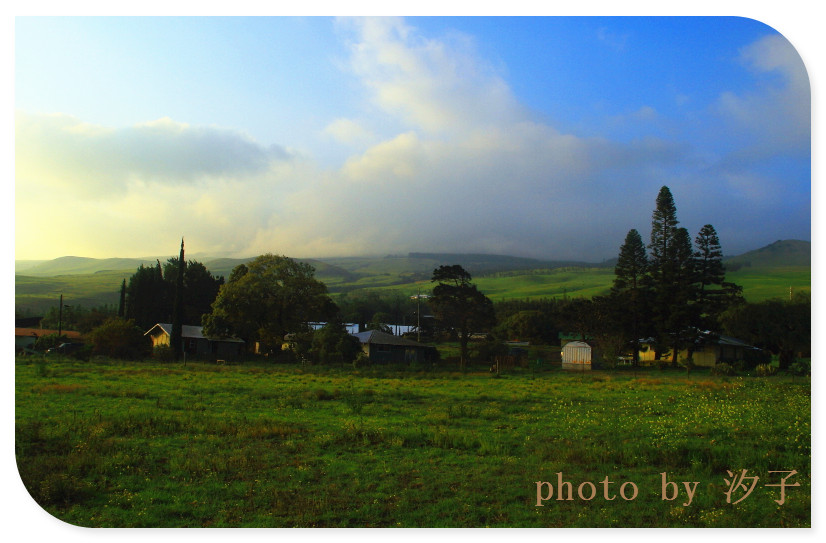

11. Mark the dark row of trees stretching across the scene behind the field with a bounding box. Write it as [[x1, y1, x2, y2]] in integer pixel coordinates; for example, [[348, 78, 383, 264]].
[[30, 187, 811, 367]]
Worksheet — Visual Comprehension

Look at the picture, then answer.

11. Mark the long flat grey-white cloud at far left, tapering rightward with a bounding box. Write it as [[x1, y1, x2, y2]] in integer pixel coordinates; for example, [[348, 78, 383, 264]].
[[15, 112, 290, 198]]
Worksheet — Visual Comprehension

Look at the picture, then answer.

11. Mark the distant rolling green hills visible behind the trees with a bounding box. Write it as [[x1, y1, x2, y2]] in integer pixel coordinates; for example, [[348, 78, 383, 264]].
[[15, 240, 811, 316]]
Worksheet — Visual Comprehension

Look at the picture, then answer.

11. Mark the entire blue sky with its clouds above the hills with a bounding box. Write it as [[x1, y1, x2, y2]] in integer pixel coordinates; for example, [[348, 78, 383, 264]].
[[14, 16, 814, 262]]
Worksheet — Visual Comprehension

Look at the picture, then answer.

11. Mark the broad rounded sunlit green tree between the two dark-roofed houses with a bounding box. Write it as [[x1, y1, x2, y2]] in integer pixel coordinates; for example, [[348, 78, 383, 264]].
[[202, 254, 338, 351]]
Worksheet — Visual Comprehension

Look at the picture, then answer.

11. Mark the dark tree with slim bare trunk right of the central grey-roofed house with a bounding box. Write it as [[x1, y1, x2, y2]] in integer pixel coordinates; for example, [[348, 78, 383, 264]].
[[428, 265, 496, 370]]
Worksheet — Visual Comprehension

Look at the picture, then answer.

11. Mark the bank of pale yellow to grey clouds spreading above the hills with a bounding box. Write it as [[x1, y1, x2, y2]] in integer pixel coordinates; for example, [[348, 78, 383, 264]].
[[15, 19, 810, 261]]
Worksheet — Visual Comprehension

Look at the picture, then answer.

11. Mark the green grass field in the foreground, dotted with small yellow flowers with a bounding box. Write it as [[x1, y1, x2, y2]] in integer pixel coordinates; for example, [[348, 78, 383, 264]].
[[15, 359, 811, 527]]
